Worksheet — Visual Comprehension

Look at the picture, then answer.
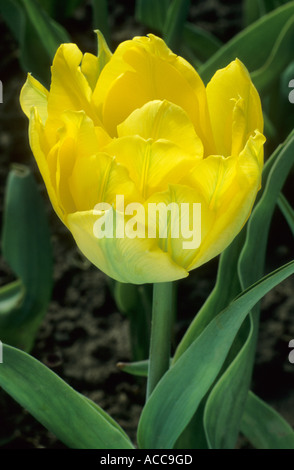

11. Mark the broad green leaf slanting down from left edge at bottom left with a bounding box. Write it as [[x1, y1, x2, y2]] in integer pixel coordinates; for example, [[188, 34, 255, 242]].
[[0, 344, 133, 449]]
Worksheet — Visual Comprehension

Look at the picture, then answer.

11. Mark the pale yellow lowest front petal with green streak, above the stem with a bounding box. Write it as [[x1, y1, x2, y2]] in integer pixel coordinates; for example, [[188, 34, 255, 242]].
[[68, 211, 188, 284]]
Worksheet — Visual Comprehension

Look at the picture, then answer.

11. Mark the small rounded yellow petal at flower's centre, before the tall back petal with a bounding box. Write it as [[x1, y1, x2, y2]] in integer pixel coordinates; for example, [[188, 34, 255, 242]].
[[117, 100, 203, 157]]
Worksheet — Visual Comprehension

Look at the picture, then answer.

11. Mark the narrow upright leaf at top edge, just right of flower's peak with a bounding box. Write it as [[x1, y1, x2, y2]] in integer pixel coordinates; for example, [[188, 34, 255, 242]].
[[163, 0, 190, 51]]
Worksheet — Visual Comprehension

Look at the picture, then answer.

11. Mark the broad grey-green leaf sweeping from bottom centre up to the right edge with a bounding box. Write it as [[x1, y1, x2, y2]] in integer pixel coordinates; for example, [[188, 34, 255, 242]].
[[138, 261, 294, 449]]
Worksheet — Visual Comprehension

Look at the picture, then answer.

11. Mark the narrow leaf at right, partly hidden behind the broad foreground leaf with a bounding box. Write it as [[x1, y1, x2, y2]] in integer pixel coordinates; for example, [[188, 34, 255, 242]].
[[204, 132, 294, 449]]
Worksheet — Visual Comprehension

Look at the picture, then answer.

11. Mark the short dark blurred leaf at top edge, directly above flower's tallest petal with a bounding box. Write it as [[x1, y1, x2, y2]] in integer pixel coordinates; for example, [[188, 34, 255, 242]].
[[135, 0, 170, 32]]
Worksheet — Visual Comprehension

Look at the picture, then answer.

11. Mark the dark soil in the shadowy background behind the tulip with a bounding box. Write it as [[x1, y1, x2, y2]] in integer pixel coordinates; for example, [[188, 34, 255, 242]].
[[0, 0, 294, 449]]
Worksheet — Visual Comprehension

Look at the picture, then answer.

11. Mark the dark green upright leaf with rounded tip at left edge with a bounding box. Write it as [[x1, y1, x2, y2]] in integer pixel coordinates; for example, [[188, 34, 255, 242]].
[[0, 165, 52, 351]]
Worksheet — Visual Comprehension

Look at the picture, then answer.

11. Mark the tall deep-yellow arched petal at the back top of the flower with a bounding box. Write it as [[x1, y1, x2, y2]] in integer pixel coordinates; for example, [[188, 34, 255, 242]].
[[93, 35, 213, 153]]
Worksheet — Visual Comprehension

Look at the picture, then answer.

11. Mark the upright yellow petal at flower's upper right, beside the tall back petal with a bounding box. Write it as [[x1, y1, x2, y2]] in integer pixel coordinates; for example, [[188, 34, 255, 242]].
[[206, 59, 263, 156]]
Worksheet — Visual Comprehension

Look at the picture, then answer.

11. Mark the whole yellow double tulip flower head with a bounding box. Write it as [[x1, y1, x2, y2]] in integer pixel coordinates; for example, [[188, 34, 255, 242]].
[[20, 34, 265, 284]]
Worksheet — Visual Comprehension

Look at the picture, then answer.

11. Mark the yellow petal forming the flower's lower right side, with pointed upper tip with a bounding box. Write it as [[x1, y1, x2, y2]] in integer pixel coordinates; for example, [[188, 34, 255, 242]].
[[187, 132, 265, 271]]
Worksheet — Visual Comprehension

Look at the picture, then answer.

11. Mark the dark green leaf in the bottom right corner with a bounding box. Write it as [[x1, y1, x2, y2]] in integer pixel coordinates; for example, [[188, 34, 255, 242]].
[[241, 392, 294, 450]]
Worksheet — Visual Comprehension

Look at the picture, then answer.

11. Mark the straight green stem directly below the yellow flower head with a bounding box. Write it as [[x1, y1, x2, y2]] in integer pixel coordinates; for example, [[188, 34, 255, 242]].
[[146, 282, 174, 399]]
